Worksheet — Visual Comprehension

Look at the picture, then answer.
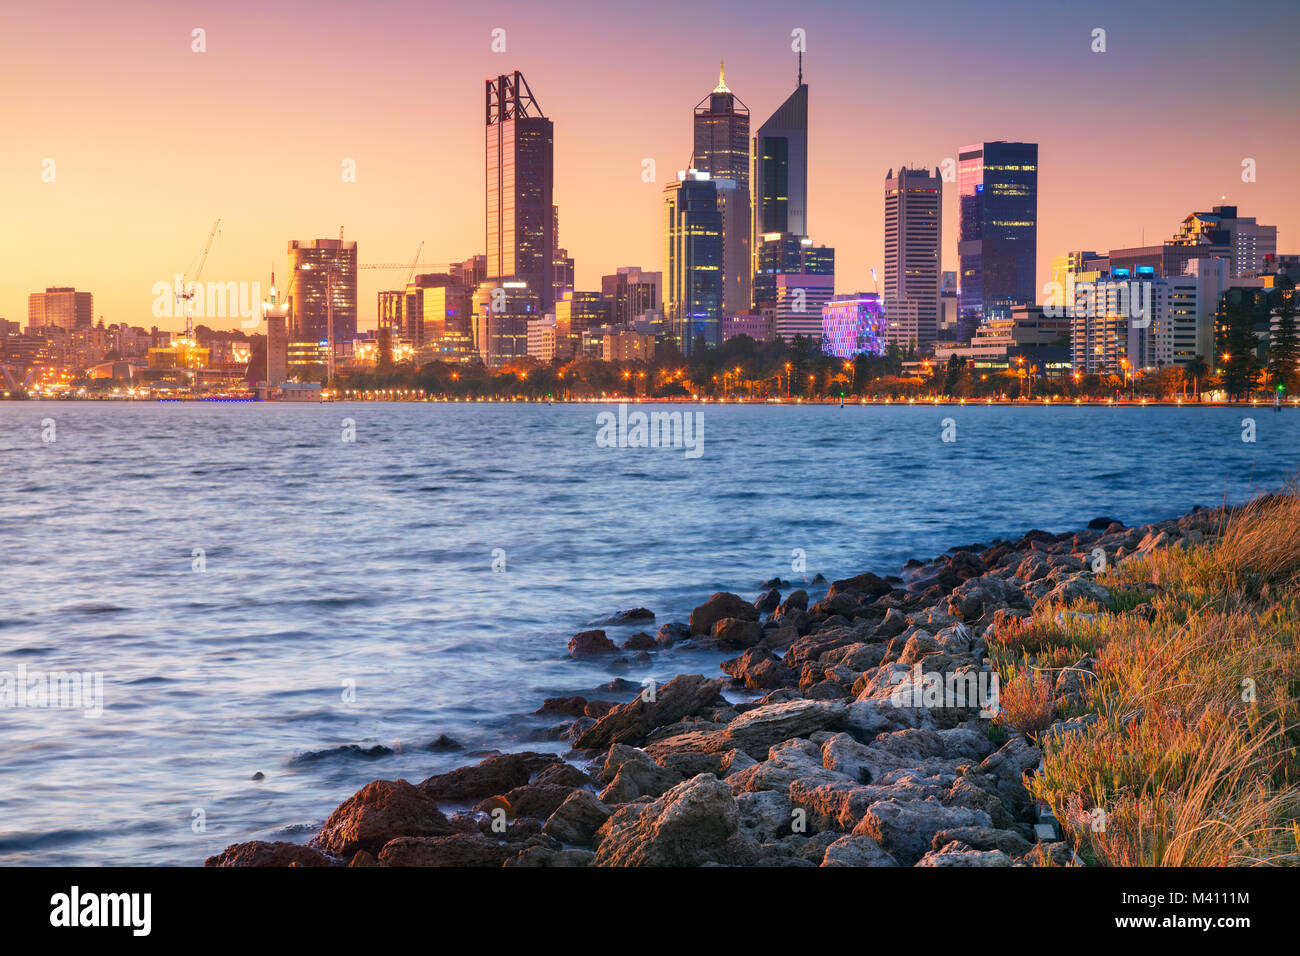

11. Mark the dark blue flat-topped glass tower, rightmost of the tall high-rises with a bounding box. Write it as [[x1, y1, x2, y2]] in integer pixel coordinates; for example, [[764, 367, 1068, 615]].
[[957, 142, 1039, 341]]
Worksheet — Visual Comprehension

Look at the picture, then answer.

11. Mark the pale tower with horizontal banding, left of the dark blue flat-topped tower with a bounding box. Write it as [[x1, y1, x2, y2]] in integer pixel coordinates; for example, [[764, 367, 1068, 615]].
[[884, 166, 944, 349]]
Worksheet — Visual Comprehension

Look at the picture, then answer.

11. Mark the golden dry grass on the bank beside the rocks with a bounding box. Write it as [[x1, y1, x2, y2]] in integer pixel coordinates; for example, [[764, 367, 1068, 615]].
[[1019, 493, 1300, 866]]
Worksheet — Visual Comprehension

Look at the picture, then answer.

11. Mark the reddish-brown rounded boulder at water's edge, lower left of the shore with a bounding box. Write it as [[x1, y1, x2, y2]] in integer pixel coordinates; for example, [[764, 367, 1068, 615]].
[[311, 780, 452, 856]]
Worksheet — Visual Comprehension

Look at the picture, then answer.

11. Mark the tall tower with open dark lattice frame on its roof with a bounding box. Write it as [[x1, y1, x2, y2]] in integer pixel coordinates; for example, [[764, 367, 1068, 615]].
[[486, 70, 555, 311]]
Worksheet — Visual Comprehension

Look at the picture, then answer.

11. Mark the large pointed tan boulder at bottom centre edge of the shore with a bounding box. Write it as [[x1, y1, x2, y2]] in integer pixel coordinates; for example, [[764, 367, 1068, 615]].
[[593, 774, 740, 866]]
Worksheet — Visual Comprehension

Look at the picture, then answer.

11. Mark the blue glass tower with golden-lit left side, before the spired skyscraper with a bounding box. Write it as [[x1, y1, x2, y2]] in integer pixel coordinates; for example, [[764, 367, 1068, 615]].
[[663, 169, 723, 355]]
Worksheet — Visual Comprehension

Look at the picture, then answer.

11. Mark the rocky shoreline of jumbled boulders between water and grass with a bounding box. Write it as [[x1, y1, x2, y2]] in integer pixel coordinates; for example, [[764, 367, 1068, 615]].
[[204, 509, 1225, 866]]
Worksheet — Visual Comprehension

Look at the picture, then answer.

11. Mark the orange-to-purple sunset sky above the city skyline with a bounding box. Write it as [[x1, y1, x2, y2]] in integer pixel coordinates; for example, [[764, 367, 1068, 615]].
[[0, 0, 1300, 329]]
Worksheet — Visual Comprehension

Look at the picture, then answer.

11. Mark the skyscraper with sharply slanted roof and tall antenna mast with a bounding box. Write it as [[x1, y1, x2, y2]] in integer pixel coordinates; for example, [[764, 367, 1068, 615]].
[[750, 69, 809, 272]]
